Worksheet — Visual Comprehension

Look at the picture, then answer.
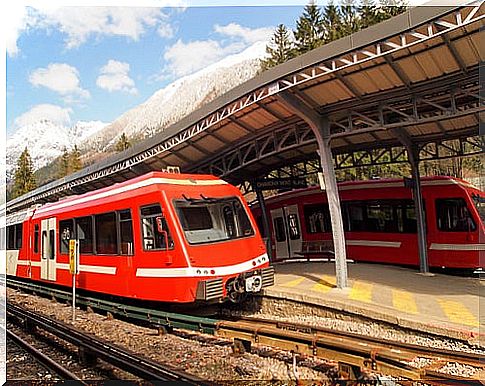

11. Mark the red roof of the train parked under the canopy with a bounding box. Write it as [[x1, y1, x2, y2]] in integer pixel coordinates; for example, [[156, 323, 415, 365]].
[[253, 176, 480, 208]]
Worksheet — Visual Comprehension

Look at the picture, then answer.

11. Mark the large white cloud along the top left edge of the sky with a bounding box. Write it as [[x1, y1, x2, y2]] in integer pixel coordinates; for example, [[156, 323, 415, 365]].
[[6, 5, 178, 57]]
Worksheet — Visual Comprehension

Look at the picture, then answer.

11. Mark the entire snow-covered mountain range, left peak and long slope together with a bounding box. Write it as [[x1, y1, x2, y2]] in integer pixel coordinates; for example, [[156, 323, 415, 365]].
[[7, 41, 266, 179]]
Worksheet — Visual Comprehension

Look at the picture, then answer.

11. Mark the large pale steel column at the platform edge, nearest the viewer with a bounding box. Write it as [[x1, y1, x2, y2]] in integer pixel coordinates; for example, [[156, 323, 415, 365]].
[[277, 92, 348, 289]]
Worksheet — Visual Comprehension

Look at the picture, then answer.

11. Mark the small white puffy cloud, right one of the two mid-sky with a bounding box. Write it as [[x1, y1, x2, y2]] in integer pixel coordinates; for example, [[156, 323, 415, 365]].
[[96, 59, 138, 94]]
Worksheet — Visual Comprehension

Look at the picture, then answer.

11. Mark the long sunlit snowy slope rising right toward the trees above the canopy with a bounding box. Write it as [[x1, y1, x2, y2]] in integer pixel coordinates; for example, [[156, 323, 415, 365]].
[[81, 42, 266, 151]]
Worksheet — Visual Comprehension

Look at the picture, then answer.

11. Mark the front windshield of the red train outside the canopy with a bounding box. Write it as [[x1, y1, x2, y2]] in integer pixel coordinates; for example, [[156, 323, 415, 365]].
[[174, 195, 254, 244]]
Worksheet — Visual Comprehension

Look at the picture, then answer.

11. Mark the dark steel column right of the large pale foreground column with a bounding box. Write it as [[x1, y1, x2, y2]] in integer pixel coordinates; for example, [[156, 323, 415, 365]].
[[394, 129, 429, 274]]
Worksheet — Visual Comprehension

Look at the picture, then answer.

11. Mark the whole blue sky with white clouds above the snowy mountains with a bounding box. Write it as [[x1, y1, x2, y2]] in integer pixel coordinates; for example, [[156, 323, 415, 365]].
[[6, 1, 305, 135]]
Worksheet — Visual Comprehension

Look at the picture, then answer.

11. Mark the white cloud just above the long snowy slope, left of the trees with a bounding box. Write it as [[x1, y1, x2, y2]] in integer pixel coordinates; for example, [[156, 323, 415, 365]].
[[159, 23, 273, 79]]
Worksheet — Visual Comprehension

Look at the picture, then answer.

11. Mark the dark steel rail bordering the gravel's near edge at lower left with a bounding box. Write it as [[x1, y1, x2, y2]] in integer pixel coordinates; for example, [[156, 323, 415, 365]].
[[7, 302, 213, 385]]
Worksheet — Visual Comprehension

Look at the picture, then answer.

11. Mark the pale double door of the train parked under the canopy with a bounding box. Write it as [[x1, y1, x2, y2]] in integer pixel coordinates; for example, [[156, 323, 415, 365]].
[[271, 205, 302, 259]]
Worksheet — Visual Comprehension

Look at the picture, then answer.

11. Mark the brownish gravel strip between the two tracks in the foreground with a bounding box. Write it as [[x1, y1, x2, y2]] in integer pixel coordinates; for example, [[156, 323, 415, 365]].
[[8, 289, 327, 384]]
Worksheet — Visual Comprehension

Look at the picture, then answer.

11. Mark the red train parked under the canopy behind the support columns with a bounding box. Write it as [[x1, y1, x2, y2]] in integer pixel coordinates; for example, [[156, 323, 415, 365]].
[[252, 177, 485, 269]]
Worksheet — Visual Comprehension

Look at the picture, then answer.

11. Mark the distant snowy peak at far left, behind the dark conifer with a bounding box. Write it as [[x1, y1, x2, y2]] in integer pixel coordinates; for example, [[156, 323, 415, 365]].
[[7, 119, 106, 179]]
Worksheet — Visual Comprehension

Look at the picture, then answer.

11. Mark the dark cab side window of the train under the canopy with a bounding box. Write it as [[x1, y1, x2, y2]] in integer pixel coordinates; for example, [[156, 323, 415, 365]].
[[436, 198, 476, 232]]
